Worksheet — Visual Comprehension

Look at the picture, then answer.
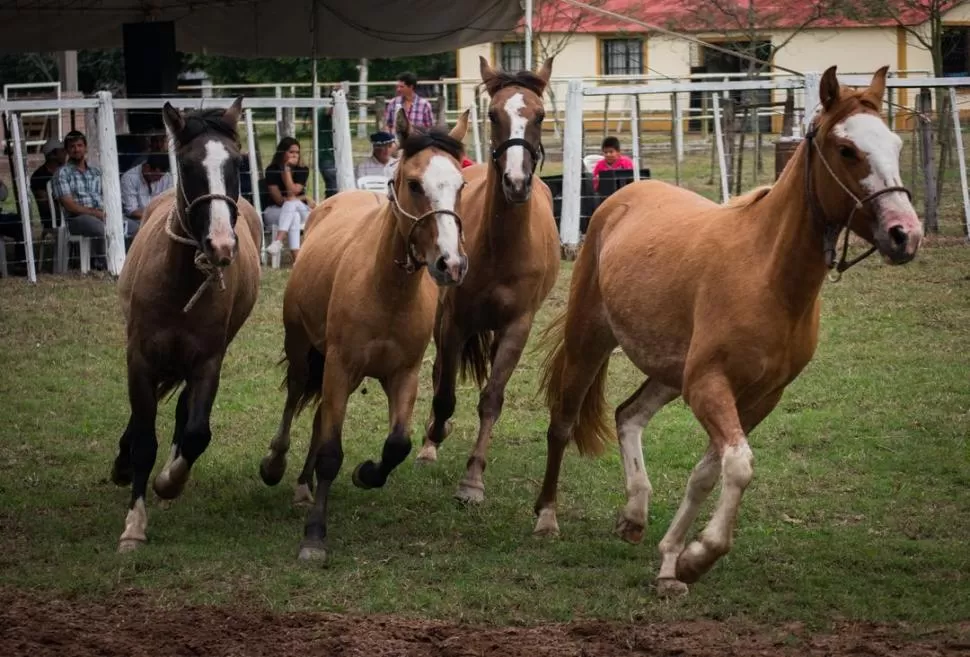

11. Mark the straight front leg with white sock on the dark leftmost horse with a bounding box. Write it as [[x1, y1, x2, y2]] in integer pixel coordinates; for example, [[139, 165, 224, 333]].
[[116, 352, 158, 552]]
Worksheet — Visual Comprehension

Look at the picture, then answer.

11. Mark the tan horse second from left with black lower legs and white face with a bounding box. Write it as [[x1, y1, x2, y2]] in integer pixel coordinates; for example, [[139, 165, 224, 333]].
[[259, 110, 468, 560]]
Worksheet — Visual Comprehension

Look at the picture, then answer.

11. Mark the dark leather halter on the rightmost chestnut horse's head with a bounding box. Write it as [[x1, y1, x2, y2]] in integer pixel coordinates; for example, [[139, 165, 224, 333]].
[[805, 123, 913, 282]]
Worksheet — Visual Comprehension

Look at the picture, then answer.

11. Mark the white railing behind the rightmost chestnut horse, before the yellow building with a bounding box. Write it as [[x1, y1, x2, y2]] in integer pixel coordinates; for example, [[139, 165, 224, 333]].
[[559, 72, 970, 249]]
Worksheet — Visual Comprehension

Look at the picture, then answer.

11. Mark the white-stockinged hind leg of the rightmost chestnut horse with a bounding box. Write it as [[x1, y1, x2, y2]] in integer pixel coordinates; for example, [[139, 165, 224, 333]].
[[615, 379, 680, 543]]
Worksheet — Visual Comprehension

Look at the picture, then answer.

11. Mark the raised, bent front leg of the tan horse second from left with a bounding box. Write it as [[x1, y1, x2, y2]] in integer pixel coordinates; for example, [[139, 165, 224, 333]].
[[352, 363, 421, 488]]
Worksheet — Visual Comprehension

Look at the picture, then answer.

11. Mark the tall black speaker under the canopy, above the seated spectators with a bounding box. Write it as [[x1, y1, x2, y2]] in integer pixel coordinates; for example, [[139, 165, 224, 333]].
[[122, 21, 178, 135]]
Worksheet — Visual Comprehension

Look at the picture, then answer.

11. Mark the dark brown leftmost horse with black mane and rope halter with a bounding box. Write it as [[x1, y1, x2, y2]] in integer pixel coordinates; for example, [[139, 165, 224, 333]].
[[111, 97, 262, 551]]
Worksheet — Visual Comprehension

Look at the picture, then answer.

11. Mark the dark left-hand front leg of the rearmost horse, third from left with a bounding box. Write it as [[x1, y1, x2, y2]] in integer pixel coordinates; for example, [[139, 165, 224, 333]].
[[417, 309, 463, 463]]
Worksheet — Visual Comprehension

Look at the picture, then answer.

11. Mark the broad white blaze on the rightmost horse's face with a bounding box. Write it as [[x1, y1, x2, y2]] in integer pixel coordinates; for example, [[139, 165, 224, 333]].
[[833, 114, 916, 214]]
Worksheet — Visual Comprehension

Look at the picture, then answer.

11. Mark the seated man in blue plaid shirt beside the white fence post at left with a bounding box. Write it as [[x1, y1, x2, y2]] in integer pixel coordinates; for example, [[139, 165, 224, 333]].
[[53, 130, 106, 269]]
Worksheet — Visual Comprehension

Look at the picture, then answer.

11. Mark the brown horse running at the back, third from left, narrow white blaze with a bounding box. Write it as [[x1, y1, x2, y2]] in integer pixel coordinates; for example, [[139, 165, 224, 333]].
[[418, 57, 560, 502]]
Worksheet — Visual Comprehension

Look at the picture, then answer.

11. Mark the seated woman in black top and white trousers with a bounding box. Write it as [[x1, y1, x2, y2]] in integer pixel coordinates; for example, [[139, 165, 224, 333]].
[[263, 137, 314, 260]]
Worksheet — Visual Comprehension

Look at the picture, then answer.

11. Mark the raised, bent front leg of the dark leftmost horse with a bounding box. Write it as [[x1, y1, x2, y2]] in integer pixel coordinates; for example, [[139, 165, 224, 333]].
[[153, 354, 222, 500]]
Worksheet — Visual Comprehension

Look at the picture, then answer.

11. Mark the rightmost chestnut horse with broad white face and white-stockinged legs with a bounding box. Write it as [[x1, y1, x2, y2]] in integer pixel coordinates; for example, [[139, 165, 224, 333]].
[[535, 67, 923, 595]]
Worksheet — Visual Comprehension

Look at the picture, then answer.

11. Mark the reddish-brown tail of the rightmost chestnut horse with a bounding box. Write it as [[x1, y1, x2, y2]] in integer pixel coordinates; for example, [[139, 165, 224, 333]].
[[539, 241, 613, 456]]
